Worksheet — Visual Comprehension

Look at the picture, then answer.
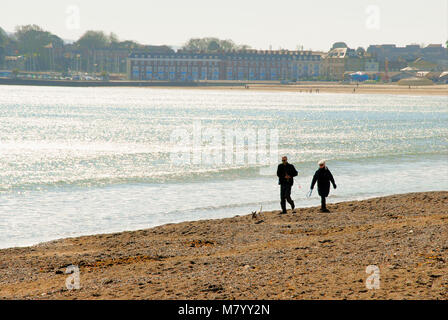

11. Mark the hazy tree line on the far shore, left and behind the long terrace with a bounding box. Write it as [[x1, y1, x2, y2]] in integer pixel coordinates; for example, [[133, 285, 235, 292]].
[[0, 25, 250, 72]]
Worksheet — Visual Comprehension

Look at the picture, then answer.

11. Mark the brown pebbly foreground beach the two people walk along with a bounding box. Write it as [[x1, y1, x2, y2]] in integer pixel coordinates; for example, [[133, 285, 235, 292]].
[[0, 191, 448, 300]]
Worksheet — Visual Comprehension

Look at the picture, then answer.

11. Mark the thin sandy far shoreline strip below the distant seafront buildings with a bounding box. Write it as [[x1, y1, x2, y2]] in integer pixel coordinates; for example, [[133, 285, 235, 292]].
[[0, 79, 448, 96]]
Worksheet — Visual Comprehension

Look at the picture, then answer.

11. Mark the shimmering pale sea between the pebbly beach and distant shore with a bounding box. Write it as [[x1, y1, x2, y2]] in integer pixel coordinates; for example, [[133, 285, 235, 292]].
[[0, 86, 448, 248]]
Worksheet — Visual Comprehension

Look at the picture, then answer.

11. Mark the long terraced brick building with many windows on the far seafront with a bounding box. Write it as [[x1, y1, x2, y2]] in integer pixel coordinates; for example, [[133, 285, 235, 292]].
[[127, 50, 322, 81]]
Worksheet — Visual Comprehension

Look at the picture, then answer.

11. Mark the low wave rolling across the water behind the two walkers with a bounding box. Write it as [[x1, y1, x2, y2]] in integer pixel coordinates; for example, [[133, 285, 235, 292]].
[[0, 150, 448, 193]]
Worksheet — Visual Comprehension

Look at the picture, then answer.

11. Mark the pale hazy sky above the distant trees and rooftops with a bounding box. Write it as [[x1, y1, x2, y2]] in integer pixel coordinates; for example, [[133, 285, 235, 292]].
[[0, 0, 448, 50]]
